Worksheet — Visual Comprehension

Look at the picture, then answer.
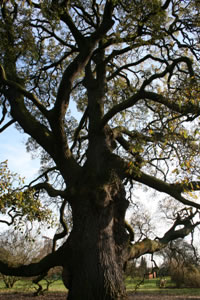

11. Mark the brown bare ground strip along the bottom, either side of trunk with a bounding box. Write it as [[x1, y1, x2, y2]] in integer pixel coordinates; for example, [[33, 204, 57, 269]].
[[0, 292, 200, 300]]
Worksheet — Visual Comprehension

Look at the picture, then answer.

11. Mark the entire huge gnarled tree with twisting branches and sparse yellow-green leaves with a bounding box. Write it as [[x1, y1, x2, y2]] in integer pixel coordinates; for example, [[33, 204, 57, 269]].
[[0, 0, 200, 300]]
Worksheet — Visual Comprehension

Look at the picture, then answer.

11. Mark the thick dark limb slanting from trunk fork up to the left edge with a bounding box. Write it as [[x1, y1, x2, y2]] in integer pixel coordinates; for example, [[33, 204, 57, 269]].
[[0, 66, 79, 180]]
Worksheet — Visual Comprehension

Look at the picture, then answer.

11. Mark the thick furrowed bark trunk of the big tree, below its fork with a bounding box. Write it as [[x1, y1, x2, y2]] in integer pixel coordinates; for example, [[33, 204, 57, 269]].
[[63, 176, 128, 300]]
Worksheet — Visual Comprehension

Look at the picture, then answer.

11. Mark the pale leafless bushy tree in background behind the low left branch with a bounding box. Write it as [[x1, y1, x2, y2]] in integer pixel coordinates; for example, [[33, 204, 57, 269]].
[[0, 225, 62, 295]]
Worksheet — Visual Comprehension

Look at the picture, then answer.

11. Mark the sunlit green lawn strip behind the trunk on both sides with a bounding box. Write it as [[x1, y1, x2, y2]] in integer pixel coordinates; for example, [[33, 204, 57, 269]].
[[0, 277, 200, 296]]
